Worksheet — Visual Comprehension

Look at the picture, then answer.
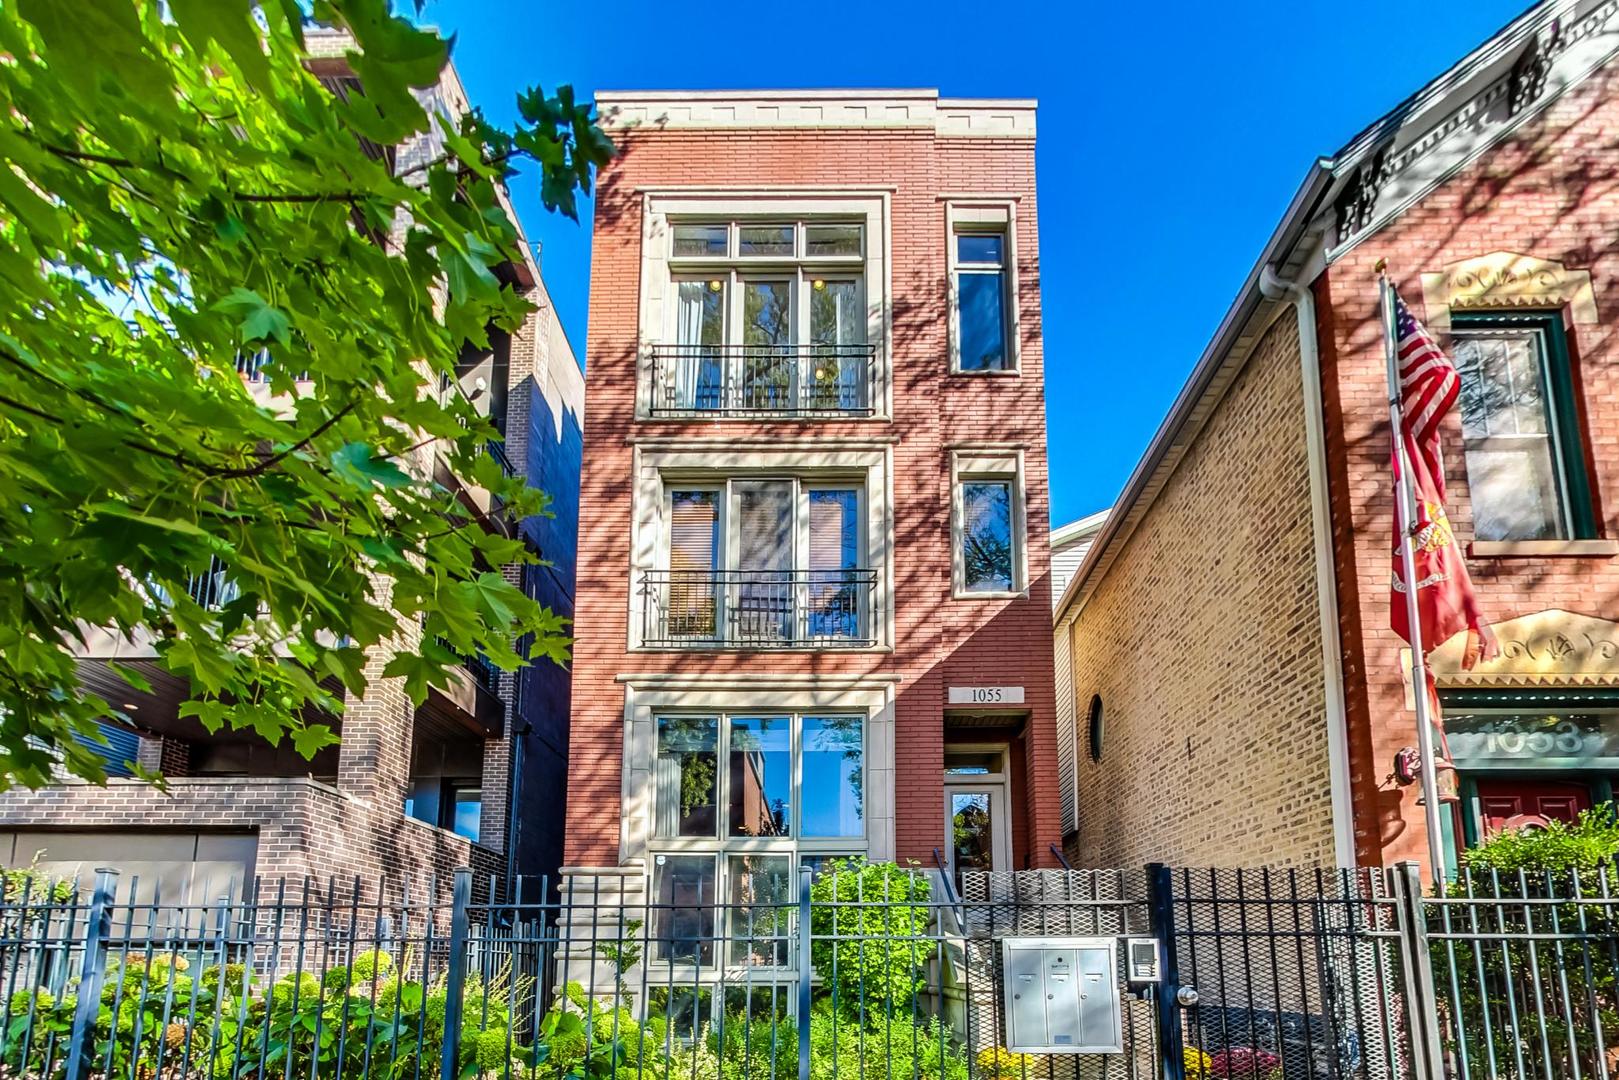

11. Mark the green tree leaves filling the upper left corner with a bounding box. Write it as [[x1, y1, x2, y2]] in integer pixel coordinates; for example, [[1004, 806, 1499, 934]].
[[0, 0, 612, 787]]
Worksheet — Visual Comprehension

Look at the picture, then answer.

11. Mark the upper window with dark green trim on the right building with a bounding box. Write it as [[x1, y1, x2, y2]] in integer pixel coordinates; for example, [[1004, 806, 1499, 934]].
[[1451, 311, 1596, 541]]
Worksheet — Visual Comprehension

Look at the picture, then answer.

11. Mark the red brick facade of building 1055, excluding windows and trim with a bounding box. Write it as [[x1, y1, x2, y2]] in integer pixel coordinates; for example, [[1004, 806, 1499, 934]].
[[567, 99, 1060, 866]]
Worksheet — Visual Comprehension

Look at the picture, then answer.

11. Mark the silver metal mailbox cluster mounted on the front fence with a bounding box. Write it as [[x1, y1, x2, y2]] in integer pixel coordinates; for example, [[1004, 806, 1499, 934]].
[[1001, 938, 1124, 1054]]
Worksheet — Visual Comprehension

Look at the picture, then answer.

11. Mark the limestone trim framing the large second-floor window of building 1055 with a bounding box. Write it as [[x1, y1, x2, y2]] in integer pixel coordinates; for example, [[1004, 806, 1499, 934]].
[[627, 442, 895, 656]]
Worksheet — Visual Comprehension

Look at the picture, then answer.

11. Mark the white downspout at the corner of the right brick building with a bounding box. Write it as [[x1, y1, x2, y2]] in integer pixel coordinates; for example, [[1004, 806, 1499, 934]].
[[1260, 262, 1355, 866]]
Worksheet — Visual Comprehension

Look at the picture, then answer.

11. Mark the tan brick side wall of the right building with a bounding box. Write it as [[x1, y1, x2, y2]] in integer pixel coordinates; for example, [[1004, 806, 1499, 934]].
[[1073, 308, 1332, 866]]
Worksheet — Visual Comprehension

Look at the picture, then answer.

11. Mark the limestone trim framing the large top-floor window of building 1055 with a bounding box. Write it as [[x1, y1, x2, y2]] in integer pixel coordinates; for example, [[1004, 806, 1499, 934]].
[[636, 188, 894, 423]]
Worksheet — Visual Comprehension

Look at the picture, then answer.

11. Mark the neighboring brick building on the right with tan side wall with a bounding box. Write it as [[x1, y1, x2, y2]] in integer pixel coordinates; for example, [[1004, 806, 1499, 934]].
[[1057, 0, 1619, 865]]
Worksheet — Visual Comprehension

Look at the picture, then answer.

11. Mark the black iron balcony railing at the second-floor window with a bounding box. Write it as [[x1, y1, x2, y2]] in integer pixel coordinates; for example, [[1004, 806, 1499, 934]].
[[641, 570, 879, 649]]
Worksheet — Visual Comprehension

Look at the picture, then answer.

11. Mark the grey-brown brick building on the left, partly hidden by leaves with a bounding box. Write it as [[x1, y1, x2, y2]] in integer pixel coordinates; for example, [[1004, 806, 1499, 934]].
[[0, 31, 584, 900]]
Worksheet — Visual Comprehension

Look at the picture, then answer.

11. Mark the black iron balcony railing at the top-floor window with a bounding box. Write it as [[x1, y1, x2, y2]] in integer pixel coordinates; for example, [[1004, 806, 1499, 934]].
[[651, 345, 876, 416]]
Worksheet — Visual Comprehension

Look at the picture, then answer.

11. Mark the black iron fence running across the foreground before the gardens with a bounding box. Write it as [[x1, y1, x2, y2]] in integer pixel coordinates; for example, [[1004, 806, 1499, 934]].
[[0, 855, 1619, 1080]]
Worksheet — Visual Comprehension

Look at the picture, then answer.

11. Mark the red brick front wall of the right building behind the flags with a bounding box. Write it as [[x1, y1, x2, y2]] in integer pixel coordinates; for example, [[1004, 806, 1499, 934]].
[[1315, 65, 1619, 865]]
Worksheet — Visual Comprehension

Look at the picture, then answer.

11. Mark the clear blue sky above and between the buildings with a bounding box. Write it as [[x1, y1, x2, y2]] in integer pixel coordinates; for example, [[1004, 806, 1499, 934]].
[[423, 0, 1525, 525]]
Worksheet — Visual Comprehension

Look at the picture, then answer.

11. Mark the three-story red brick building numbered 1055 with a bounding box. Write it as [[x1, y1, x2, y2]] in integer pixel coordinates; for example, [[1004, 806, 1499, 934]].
[[567, 91, 1060, 932]]
